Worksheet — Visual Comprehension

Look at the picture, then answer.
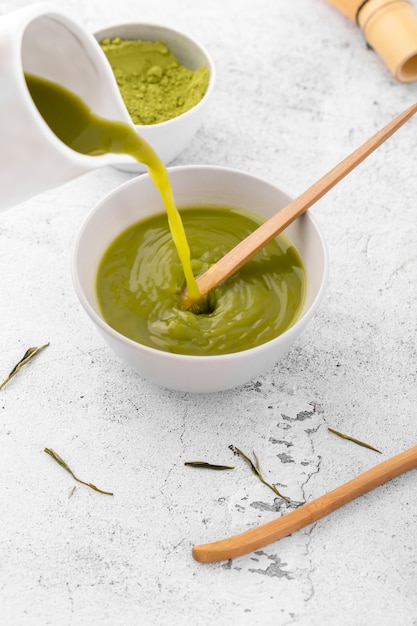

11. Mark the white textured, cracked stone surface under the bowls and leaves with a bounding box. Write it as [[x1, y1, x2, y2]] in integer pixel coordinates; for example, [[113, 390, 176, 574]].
[[0, 0, 417, 626]]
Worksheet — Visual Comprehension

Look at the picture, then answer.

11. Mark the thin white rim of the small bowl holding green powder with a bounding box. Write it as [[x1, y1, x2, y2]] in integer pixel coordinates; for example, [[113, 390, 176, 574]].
[[92, 22, 217, 131]]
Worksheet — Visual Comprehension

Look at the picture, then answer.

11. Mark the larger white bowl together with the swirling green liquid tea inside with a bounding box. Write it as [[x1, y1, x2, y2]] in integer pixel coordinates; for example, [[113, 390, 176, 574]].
[[73, 166, 328, 393]]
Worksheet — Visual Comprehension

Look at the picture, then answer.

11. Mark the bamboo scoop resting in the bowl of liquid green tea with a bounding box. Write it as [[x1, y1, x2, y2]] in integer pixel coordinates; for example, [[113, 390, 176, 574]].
[[182, 104, 417, 309]]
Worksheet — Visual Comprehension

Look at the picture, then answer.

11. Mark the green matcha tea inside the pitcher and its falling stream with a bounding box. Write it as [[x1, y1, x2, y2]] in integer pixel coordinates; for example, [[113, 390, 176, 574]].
[[25, 73, 200, 300]]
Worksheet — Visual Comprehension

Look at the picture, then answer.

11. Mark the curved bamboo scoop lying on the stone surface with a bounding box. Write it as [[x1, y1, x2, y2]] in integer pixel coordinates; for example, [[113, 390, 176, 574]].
[[193, 446, 417, 563]]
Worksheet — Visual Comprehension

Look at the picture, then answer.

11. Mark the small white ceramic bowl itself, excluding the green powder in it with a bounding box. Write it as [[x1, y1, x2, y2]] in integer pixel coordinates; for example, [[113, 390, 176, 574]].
[[94, 23, 215, 172]]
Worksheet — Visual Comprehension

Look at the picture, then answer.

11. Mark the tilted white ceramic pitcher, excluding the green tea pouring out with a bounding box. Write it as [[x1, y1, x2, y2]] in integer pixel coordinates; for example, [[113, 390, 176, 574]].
[[0, 4, 134, 210]]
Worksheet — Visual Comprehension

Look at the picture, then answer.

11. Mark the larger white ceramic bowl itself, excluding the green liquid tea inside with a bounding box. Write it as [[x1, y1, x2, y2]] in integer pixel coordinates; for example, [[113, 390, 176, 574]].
[[72, 165, 329, 392]]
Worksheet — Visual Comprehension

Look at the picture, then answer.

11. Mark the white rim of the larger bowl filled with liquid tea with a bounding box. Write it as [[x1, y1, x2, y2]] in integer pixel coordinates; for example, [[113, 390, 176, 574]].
[[71, 165, 330, 363]]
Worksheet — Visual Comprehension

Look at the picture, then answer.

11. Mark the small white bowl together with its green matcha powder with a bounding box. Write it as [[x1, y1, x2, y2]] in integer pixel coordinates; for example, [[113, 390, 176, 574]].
[[94, 23, 215, 172]]
